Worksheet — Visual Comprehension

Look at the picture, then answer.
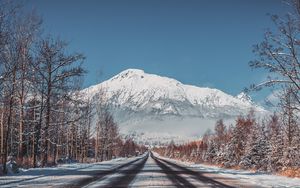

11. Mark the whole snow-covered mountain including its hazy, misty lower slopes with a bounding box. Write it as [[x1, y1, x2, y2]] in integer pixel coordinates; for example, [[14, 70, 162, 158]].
[[82, 69, 266, 145]]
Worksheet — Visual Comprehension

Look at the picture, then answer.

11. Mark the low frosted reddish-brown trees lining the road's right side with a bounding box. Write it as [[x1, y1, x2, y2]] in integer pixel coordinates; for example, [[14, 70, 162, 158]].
[[156, 112, 300, 176]]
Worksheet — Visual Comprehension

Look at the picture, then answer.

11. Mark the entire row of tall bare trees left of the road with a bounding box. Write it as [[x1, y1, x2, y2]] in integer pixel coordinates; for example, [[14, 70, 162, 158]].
[[0, 1, 145, 173]]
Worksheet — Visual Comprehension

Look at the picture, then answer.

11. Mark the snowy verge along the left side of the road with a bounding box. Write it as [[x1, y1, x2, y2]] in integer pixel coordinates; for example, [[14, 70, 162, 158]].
[[0, 155, 144, 188]]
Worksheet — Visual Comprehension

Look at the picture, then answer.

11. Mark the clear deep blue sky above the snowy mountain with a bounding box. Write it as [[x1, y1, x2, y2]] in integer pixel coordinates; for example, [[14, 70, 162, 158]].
[[25, 0, 288, 101]]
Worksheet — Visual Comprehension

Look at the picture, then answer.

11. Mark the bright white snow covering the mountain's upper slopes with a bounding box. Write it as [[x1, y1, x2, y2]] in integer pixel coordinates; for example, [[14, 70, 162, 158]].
[[83, 69, 264, 115]]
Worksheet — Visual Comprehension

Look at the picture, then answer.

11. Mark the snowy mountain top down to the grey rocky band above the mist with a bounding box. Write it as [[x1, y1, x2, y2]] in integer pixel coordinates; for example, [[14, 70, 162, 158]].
[[84, 69, 264, 118]]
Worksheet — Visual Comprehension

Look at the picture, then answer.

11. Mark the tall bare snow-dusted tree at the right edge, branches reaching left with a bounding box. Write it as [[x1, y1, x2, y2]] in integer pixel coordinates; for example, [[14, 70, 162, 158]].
[[250, 0, 300, 175]]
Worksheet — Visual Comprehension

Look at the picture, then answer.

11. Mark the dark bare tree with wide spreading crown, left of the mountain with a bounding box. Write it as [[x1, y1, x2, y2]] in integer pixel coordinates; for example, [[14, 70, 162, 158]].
[[34, 37, 85, 166]]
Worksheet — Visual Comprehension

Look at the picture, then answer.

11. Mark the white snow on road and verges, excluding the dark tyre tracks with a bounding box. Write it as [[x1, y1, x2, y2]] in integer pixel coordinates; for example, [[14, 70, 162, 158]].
[[0, 153, 300, 188]]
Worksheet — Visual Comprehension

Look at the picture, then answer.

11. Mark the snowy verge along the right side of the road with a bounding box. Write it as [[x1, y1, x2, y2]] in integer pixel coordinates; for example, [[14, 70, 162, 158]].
[[153, 152, 300, 188]]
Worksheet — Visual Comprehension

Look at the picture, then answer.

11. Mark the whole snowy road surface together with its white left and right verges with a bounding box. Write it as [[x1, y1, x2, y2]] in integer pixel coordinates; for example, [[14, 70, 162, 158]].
[[0, 153, 297, 188]]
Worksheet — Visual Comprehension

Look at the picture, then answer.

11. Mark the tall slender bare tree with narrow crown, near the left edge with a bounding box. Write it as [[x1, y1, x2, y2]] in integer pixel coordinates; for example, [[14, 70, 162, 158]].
[[14, 13, 41, 160]]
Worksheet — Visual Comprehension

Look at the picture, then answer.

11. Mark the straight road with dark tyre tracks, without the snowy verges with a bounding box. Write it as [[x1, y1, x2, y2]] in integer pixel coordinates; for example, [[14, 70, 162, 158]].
[[74, 153, 251, 188]]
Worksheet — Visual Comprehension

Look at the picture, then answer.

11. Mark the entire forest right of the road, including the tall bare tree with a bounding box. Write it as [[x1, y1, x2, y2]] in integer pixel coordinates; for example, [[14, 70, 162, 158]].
[[156, 1, 300, 177]]
